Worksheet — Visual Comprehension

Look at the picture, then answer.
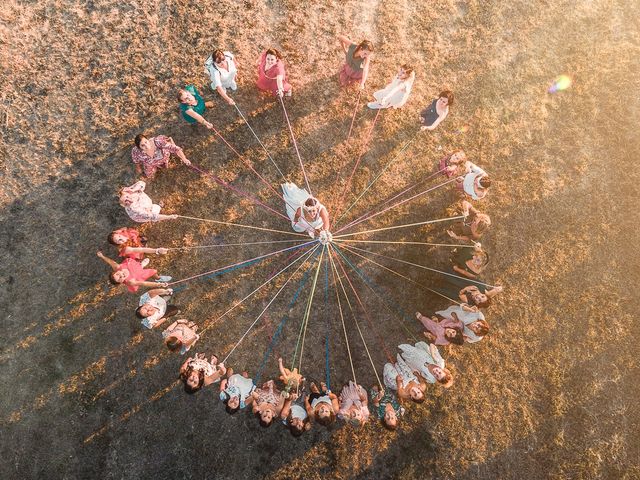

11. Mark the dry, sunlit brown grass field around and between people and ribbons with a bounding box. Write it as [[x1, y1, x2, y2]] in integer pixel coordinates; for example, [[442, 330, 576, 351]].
[[0, 0, 640, 479]]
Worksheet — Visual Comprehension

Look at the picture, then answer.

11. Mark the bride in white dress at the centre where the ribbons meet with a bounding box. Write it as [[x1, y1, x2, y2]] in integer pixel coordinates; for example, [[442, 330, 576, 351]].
[[281, 183, 330, 238]]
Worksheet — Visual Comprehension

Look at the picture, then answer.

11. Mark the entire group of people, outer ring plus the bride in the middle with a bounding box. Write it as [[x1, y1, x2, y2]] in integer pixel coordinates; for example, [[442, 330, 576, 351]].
[[97, 36, 502, 436]]
